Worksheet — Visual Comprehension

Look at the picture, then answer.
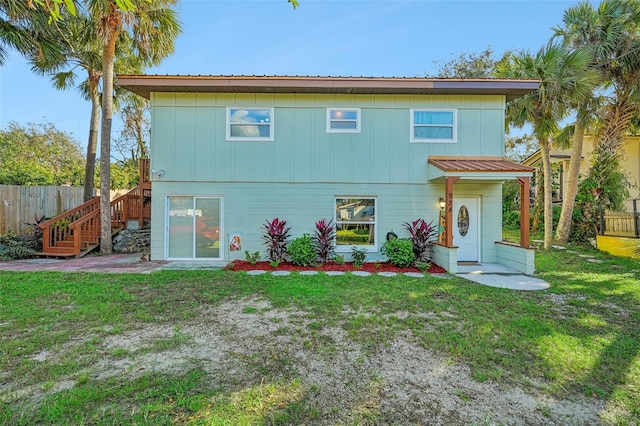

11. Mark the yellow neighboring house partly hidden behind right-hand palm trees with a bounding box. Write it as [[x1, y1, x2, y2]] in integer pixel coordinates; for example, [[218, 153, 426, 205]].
[[522, 135, 640, 211]]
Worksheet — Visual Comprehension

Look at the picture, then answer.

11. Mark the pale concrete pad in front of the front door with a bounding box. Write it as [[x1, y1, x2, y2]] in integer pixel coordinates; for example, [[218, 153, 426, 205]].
[[456, 263, 549, 290]]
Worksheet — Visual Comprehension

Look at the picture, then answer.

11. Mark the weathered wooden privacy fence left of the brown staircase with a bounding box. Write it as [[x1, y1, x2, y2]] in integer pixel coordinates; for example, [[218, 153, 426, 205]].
[[0, 185, 83, 234]]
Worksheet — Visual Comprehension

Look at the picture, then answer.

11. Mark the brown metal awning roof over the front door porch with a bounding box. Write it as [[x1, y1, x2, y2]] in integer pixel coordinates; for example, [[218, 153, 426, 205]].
[[428, 155, 533, 180]]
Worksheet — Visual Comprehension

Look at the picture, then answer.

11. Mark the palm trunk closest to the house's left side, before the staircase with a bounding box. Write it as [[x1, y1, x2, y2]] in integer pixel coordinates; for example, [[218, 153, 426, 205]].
[[100, 30, 117, 254]]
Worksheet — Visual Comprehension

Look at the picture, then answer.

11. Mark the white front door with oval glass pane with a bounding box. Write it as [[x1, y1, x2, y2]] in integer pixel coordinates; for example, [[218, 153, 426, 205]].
[[453, 197, 480, 262]]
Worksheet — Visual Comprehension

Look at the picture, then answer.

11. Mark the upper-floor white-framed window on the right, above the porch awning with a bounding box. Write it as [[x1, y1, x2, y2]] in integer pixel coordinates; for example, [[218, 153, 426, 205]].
[[411, 109, 457, 143]]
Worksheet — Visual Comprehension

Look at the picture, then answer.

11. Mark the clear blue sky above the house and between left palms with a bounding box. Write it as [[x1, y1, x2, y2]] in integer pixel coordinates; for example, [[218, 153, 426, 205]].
[[0, 0, 576, 147]]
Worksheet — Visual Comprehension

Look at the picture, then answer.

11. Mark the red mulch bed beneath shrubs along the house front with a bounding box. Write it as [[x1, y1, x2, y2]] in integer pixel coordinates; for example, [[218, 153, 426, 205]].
[[226, 260, 447, 274]]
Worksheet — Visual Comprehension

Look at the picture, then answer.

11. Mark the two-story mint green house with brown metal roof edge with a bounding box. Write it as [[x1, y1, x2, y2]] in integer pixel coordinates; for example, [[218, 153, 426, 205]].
[[118, 75, 538, 274]]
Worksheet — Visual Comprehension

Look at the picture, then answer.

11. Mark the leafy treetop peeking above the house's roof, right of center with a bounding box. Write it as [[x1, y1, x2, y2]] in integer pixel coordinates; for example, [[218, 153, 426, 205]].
[[434, 47, 510, 78]]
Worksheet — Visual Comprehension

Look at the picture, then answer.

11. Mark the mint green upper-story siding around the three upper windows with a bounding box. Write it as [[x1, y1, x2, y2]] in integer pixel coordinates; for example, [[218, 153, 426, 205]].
[[152, 93, 504, 183]]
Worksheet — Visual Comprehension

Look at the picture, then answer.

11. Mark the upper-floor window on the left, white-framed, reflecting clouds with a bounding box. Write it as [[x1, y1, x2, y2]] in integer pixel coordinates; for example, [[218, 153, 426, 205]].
[[227, 108, 273, 141]]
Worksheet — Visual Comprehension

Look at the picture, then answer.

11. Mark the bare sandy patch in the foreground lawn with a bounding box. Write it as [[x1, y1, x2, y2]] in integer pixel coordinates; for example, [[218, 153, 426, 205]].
[[3, 298, 603, 425]]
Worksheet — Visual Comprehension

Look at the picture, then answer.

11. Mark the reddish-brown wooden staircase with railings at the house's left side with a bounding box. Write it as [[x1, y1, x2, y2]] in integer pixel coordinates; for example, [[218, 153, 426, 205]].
[[38, 159, 151, 257]]
